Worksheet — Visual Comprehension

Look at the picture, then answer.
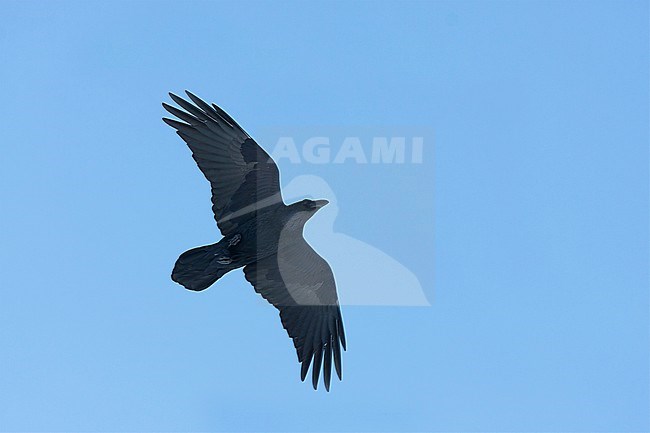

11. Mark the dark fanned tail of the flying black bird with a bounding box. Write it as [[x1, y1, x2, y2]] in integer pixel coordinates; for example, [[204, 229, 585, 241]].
[[172, 244, 237, 291]]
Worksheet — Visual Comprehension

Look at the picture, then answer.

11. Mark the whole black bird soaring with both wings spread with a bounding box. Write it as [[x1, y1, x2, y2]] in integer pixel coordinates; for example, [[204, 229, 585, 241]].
[[163, 91, 345, 391]]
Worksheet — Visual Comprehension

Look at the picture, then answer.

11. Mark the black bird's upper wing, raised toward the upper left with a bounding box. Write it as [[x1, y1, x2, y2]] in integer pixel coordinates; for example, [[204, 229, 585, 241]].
[[163, 91, 282, 236]]
